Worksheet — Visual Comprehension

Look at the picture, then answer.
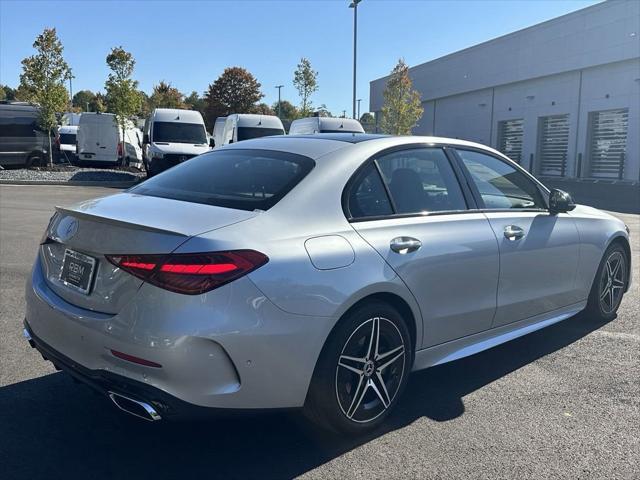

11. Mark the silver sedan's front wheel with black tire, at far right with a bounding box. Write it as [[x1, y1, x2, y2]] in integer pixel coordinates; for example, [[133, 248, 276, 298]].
[[585, 242, 629, 322]]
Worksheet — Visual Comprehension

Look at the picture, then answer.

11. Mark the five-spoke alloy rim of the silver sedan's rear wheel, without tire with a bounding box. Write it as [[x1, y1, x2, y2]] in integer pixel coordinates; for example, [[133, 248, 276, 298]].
[[336, 317, 406, 423]]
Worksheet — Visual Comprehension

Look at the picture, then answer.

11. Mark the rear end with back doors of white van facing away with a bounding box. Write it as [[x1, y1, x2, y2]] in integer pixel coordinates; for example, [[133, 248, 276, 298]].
[[77, 112, 120, 165]]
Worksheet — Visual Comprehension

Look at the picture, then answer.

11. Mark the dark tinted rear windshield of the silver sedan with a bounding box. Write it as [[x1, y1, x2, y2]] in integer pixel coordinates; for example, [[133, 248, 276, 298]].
[[129, 150, 315, 211]]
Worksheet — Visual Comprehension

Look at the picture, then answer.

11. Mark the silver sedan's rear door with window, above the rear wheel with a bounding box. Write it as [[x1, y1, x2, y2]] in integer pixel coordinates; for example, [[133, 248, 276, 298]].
[[348, 147, 499, 347]]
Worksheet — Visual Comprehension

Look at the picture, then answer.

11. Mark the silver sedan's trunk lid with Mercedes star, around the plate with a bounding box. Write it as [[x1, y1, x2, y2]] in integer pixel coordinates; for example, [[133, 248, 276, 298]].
[[40, 193, 257, 314]]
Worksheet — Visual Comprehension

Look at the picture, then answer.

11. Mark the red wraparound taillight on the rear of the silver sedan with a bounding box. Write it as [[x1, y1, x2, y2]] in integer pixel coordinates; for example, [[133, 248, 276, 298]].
[[106, 250, 269, 295]]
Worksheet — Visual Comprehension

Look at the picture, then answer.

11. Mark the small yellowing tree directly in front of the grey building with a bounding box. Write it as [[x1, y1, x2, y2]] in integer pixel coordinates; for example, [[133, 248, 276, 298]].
[[380, 58, 424, 135]]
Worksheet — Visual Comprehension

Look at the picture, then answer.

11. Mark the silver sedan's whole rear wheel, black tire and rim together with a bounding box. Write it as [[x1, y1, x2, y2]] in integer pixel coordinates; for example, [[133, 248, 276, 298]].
[[305, 301, 413, 435]]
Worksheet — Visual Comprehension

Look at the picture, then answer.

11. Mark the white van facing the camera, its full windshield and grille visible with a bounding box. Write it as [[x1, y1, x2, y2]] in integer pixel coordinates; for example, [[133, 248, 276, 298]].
[[143, 108, 210, 176]]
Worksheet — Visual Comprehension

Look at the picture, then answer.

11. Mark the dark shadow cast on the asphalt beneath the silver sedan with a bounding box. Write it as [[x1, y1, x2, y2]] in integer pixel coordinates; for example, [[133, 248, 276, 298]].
[[0, 315, 603, 480]]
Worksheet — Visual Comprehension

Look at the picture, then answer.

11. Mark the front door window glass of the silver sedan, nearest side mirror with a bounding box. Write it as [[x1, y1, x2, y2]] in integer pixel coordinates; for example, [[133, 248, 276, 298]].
[[457, 150, 546, 209]]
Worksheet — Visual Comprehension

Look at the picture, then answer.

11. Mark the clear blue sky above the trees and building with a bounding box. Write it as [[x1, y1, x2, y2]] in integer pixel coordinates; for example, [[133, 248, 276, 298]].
[[0, 0, 597, 114]]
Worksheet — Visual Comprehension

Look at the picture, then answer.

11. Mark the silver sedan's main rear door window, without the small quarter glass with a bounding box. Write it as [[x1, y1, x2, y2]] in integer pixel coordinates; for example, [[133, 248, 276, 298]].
[[377, 148, 467, 213]]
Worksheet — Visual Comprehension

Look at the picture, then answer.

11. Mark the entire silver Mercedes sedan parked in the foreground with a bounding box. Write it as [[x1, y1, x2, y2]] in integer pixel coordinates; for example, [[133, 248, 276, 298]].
[[24, 134, 631, 434]]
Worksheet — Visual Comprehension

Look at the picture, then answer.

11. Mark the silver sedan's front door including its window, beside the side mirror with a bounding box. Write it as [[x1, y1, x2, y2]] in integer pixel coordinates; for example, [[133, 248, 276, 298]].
[[456, 148, 581, 327]]
